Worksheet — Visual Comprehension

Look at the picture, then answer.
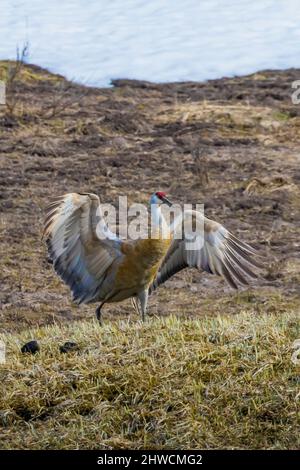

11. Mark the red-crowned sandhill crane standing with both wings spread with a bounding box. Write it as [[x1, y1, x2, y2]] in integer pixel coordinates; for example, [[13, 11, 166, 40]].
[[44, 192, 260, 324]]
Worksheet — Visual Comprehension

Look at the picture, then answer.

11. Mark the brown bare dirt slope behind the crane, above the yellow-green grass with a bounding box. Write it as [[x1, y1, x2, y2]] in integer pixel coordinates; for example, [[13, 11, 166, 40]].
[[0, 61, 300, 332]]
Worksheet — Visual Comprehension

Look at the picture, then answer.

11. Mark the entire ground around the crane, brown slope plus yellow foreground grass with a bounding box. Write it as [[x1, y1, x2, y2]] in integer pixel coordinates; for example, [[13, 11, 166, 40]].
[[0, 62, 300, 448]]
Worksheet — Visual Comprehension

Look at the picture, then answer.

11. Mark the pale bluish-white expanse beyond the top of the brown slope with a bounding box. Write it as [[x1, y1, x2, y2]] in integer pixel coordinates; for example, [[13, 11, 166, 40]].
[[0, 0, 300, 86]]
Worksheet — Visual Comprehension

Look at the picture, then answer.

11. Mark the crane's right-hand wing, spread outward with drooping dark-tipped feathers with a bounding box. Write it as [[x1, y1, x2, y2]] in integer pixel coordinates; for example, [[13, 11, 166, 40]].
[[149, 211, 262, 292]]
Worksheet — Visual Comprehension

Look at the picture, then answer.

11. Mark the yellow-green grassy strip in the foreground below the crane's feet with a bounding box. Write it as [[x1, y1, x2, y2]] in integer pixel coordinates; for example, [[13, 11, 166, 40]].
[[0, 313, 300, 449]]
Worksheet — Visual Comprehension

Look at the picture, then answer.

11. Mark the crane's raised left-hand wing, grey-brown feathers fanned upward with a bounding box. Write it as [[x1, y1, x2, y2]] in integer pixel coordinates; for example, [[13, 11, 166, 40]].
[[43, 193, 122, 303]]
